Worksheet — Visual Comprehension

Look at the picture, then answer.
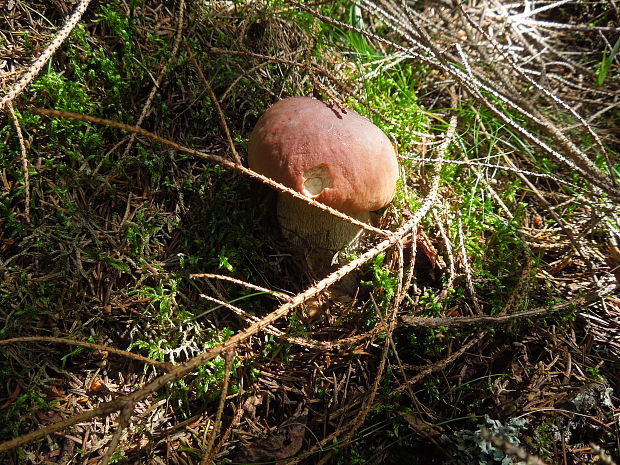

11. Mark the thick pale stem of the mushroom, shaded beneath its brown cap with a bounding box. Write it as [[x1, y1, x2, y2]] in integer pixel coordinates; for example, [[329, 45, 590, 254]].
[[278, 194, 370, 256]]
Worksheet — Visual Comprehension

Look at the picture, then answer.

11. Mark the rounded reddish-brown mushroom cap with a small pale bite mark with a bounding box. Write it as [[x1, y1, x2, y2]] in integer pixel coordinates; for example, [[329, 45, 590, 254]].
[[248, 97, 398, 213]]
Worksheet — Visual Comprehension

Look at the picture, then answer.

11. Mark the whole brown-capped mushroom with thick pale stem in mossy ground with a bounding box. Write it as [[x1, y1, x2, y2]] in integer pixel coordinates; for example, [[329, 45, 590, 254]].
[[248, 97, 398, 255]]
